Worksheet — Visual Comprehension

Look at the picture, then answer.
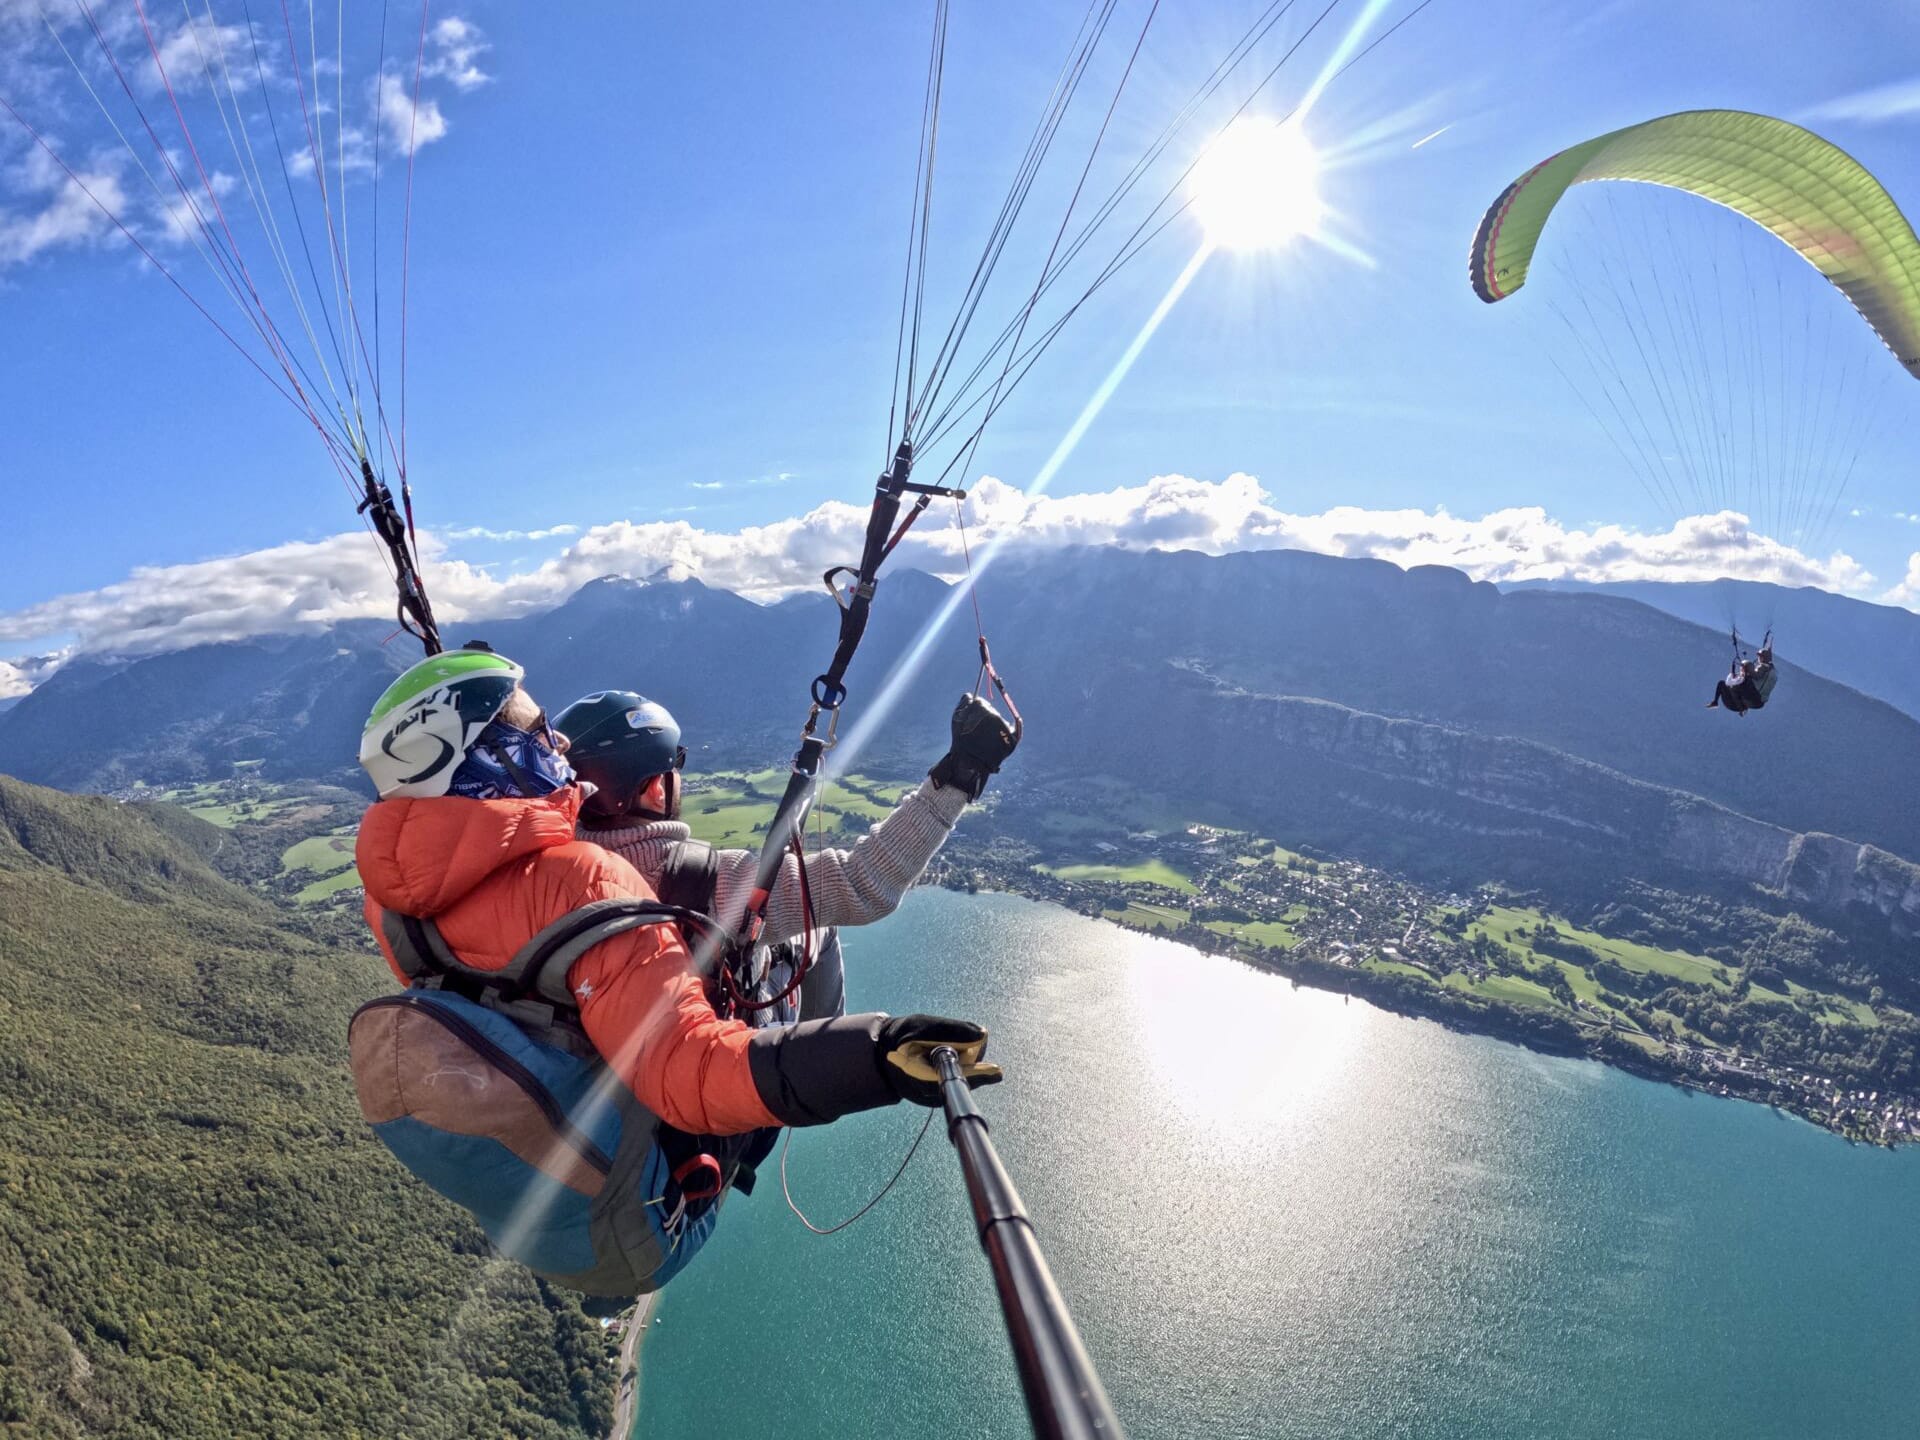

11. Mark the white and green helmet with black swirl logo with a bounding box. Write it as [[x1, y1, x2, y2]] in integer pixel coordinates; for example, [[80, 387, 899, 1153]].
[[361, 649, 526, 801]]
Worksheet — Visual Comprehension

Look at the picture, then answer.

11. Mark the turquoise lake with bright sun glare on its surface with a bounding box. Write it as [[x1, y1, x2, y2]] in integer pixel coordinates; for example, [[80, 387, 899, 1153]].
[[636, 891, 1920, 1440]]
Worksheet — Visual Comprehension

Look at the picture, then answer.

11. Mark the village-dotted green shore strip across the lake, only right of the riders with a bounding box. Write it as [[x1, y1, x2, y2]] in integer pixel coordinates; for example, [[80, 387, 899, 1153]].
[[924, 787, 1920, 1146]]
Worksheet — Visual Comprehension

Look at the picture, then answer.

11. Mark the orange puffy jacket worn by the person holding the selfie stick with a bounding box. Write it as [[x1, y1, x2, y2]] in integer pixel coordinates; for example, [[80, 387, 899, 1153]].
[[353, 785, 781, 1135]]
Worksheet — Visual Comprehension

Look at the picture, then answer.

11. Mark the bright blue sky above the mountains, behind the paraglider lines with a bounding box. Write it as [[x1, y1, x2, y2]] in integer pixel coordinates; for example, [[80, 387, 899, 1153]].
[[0, 0, 1920, 675]]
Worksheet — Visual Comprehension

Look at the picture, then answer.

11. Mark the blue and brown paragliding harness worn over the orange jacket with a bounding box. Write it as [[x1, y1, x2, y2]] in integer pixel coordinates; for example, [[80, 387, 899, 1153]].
[[349, 841, 841, 1298]]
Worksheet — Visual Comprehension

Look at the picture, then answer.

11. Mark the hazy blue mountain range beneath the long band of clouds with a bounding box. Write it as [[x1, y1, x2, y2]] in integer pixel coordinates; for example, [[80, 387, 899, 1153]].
[[0, 549, 1920, 939]]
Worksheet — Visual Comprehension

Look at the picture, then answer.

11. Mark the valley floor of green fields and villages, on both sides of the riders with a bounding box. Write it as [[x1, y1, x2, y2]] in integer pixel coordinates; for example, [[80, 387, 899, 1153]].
[[153, 770, 1920, 1144]]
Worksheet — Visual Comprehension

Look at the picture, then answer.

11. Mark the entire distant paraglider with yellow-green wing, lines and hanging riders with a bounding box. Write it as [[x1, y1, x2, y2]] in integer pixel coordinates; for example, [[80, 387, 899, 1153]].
[[1469, 109, 1920, 714]]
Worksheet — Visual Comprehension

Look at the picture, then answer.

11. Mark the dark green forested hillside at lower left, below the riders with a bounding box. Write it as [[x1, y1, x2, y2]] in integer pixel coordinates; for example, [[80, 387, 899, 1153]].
[[0, 780, 612, 1440]]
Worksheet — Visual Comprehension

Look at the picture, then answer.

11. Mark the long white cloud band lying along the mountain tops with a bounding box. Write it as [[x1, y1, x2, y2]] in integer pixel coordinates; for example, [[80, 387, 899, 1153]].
[[0, 474, 1889, 653]]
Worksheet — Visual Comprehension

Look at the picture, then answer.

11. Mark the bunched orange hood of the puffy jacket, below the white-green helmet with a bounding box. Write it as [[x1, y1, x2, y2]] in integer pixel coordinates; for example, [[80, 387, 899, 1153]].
[[353, 785, 582, 918]]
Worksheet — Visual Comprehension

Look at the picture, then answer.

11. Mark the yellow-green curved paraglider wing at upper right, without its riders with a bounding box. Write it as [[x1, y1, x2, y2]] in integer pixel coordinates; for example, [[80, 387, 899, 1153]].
[[1471, 109, 1920, 378]]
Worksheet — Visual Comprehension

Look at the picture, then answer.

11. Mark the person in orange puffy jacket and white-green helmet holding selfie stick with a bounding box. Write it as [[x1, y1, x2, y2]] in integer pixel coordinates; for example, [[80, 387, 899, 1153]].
[[355, 649, 1000, 1135]]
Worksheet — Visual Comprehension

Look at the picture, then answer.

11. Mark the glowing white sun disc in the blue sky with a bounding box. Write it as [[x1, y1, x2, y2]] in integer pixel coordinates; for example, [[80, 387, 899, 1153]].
[[1188, 115, 1325, 250]]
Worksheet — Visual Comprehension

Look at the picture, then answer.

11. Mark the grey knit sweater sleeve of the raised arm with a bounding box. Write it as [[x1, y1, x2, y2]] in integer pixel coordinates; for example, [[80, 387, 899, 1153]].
[[714, 780, 966, 943]]
